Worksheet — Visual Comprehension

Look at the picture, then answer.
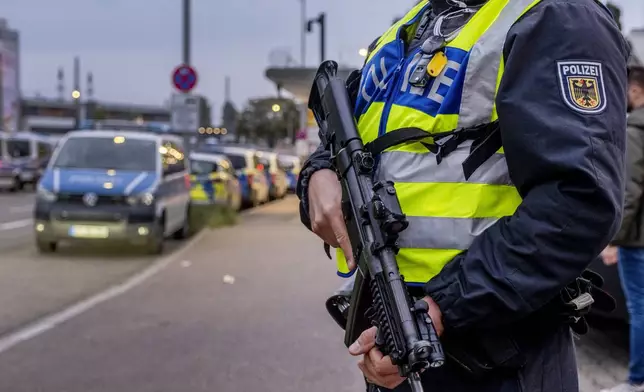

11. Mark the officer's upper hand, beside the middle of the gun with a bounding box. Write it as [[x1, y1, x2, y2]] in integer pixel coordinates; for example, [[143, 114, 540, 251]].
[[309, 169, 355, 270]]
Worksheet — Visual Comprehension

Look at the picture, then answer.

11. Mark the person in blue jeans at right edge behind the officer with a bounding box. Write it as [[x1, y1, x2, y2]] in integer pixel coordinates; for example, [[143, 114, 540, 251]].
[[602, 67, 644, 392]]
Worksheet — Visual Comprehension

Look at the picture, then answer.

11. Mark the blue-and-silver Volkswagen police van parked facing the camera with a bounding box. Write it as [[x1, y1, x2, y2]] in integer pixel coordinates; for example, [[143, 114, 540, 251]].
[[34, 130, 190, 254]]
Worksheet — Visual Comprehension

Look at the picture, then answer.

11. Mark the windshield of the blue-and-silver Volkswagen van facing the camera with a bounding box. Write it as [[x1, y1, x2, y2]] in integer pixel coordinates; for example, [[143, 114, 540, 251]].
[[53, 136, 159, 171]]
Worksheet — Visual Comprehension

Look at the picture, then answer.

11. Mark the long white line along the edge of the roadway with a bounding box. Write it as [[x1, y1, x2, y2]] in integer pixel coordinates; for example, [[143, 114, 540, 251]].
[[0, 204, 284, 354]]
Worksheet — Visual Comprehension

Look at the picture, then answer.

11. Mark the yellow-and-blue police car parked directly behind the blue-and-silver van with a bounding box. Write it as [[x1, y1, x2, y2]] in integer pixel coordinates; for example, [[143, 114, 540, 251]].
[[190, 152, 242, 211]]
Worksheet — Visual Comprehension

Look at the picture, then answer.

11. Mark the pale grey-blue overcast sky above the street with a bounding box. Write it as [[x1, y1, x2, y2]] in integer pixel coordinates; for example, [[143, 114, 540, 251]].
[[0, 0, 644, 119]]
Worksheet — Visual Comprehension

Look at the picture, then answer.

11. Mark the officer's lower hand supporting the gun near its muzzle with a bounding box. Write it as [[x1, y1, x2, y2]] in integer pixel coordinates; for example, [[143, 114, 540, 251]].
[[349, 327, 405, 389]]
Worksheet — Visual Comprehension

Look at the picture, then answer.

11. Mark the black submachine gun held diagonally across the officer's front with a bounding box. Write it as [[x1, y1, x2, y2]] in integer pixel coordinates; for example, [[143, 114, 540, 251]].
[[309, 61, 445, 392]]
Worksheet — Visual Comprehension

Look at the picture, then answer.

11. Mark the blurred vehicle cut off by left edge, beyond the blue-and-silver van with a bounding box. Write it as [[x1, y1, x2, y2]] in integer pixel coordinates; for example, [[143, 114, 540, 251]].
[[0, 132, 55, 192]]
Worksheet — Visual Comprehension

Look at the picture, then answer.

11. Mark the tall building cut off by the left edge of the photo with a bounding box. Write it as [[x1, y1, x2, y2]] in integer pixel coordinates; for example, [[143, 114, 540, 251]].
[[0, 18, 20, 132]]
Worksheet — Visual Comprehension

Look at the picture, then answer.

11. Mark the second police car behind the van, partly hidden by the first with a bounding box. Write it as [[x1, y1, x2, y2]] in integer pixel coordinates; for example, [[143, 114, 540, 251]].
[[195, 144, 270, 207]]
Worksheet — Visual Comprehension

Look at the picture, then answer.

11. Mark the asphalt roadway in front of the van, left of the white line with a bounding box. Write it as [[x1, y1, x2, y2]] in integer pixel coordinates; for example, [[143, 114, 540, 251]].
[[0, 192, 179, 338]]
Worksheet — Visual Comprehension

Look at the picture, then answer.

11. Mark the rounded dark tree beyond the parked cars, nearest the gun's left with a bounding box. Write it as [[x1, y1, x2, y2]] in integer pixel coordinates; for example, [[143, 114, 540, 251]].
[[237, 97, 300, 148]]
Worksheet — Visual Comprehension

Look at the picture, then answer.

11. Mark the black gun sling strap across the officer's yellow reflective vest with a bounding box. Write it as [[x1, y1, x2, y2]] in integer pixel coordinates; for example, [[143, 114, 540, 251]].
[[365, 121, 502, 180]]
